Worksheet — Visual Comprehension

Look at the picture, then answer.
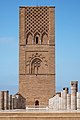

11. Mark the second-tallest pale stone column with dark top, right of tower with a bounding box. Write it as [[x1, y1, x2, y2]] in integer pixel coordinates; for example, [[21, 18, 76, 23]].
[[61, 87, 68, 110]]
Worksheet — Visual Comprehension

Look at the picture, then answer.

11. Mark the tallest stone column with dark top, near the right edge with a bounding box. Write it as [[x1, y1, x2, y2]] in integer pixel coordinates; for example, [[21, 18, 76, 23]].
[[71, 81, 78, 110]]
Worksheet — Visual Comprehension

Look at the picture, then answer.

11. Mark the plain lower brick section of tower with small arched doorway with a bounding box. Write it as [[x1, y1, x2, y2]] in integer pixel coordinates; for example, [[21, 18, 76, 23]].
[[19, 75, 55, 108]]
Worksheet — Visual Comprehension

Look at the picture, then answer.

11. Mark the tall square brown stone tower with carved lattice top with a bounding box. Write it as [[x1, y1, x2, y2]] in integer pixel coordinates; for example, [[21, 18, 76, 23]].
[[19, 6, 55, 107]]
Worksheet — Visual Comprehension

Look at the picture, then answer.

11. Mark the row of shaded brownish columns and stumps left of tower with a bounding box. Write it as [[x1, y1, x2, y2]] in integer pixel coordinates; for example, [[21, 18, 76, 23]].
[[0, 91, 25, 110]]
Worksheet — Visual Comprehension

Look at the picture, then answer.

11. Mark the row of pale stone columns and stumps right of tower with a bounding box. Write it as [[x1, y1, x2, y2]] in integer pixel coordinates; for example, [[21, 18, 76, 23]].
[[49, 81, 80, 110]]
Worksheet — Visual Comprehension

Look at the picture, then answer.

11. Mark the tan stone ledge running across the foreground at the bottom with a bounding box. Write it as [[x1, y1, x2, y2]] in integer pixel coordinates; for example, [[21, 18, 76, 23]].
[[0, 110, 80, 120]]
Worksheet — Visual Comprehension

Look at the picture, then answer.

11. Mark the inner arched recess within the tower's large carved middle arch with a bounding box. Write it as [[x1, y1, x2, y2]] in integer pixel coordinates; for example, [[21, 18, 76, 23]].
[[31, 58, 41, 74]]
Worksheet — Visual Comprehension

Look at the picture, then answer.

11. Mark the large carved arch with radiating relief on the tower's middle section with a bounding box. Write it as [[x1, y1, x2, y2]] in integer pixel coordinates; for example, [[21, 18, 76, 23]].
[[26, 53, 48, 74]]
